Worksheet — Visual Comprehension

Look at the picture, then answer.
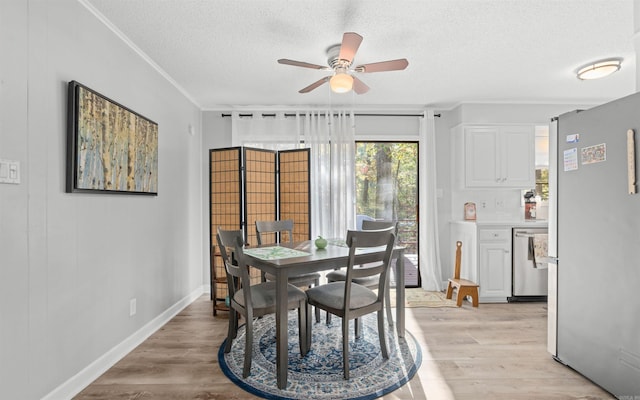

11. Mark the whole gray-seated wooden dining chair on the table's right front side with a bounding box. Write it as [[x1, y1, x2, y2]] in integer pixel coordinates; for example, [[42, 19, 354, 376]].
[[307, 230, 395, 379]]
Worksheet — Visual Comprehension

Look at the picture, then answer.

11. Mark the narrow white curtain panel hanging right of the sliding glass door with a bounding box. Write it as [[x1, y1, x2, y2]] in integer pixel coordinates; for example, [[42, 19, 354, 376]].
[[418, 110, 443, 291]]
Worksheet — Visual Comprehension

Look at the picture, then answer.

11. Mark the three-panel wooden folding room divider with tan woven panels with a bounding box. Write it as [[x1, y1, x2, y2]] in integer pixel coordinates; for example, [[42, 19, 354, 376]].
[[209, 147, 311, 315]]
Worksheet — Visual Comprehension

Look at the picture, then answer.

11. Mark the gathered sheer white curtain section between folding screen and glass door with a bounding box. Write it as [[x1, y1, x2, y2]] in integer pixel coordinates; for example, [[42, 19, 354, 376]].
[[298, 111, 355, 238]]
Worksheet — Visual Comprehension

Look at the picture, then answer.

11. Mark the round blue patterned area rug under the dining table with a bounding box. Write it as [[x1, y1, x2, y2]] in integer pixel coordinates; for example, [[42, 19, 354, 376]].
[[218, 311, 422, 400]]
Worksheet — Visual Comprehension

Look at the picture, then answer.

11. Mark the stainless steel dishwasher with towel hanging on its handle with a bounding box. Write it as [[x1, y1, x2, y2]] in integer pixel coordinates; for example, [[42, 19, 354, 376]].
[[508, 228, 548, 302]]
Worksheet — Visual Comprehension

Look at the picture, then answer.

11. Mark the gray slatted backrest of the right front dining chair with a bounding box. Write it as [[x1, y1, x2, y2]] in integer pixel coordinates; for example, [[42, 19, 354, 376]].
[[345, 227, 395, 304]]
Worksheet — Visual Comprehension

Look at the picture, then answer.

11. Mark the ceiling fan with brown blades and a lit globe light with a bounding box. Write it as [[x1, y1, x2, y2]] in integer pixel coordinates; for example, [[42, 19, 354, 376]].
[[278, 32, 409, 94]]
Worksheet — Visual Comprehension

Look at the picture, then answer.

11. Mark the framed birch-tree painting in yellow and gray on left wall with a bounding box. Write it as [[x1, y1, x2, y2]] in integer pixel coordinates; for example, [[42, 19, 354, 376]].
[[66, 81, 158, 196]]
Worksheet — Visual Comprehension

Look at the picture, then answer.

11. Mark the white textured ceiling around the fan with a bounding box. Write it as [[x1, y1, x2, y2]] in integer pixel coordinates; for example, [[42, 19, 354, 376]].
[[80, 0, 636, 110]]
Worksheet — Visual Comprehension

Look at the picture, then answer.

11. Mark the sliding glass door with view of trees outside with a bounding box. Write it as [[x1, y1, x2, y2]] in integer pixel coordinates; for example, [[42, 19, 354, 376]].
[[355, 141, 420, 287]]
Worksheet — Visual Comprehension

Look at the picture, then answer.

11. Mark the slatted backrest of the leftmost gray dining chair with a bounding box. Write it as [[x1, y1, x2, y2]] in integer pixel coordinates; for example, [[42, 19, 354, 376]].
[[216, 228, 251, 310]]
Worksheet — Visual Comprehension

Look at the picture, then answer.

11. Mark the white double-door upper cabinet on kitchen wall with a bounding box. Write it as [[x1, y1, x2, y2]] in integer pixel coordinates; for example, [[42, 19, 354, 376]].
[[463, 125, 535, 188]]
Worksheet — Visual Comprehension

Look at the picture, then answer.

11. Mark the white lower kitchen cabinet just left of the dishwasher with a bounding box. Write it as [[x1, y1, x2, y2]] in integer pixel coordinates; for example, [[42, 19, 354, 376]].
[[478, 227, 511, 303]]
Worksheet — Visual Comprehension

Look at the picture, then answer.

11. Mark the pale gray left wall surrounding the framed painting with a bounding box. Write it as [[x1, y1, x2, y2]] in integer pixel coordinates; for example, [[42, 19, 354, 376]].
[[0, 0, 205, 399]]
